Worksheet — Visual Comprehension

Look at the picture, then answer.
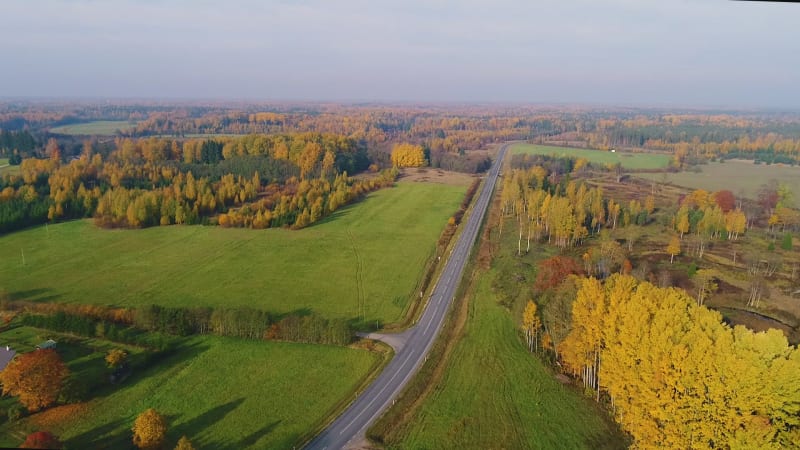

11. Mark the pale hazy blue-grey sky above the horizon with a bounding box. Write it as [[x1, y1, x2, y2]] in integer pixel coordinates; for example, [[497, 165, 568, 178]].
[[0, 0, 800, 109]]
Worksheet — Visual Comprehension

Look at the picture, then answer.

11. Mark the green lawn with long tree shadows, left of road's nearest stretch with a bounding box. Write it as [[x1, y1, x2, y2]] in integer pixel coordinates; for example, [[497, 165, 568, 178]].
[[0, 337, 381, 449]]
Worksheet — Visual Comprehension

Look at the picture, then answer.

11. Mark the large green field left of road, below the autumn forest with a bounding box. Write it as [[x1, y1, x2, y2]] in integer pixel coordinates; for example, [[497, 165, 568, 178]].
[[0, 183, 466, 323]]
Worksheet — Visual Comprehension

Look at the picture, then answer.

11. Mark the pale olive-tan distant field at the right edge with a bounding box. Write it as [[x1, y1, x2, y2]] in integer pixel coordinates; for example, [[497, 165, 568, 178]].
[[636, 160, 800, 206]]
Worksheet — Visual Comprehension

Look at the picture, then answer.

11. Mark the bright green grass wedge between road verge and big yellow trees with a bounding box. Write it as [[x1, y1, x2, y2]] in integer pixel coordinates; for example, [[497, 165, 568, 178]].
[[388, 270, 625, 449]]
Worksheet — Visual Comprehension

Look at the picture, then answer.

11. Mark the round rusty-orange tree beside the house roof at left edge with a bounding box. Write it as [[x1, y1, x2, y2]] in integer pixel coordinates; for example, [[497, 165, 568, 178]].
[[0, 349, 69, 411]]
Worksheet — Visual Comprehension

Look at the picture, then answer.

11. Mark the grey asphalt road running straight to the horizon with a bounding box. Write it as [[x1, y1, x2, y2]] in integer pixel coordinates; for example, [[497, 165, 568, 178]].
[[306, 143, 510, 450]]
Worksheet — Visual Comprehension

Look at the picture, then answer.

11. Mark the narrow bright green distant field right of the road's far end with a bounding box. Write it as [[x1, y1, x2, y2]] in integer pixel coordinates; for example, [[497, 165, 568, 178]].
[[511, 144, 672, 169]]
